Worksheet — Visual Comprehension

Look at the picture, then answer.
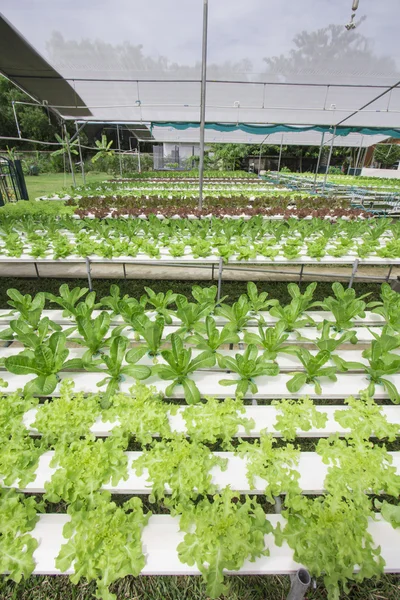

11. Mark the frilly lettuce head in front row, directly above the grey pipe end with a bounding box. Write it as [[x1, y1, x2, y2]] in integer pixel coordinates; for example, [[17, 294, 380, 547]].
[[274, 494, 385, 600]]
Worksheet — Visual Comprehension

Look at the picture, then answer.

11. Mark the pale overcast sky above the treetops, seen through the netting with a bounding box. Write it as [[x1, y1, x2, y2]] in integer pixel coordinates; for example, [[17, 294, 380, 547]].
[[0, 0, 400, 71]]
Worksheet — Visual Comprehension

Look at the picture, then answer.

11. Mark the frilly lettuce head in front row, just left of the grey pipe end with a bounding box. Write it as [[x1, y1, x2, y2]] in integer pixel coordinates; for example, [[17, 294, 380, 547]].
[[178, 488, 272, 598]]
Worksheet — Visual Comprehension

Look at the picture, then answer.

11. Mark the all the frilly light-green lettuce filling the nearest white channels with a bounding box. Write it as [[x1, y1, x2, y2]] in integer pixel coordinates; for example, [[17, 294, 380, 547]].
[[0, 382, 400, 600]]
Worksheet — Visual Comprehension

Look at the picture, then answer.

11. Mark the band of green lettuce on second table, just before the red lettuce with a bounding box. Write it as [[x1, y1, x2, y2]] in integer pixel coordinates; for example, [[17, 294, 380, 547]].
[[0, 215, 400, 262]]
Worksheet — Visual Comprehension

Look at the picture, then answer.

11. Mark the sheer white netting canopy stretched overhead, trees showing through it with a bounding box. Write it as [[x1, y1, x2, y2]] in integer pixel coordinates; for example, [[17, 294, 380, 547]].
[[0, 0, 400, 131]]
